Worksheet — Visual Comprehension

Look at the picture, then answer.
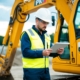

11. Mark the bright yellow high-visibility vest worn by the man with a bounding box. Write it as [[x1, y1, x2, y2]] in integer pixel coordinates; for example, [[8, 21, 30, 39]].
[[22, 29, 50, 68]]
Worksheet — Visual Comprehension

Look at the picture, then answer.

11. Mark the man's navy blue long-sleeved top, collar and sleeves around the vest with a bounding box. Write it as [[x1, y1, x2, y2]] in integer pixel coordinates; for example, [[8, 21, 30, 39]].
[[21, 25, 58, 58]]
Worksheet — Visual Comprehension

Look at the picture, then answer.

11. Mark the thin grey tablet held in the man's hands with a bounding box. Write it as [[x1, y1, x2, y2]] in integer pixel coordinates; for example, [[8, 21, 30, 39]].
[[51, 42, 70, 53]]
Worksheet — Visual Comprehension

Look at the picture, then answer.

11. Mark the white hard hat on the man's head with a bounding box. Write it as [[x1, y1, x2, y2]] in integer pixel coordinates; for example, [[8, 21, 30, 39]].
[[35, 8, 52, 23]]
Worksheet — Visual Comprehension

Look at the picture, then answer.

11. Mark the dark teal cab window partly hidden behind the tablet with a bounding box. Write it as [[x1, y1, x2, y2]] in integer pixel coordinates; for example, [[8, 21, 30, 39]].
[[58, 14, 70, 60]]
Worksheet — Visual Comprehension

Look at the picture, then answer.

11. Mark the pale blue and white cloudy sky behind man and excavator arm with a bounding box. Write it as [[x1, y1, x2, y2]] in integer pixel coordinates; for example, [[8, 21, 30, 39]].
[[0, 0, 57, 36]]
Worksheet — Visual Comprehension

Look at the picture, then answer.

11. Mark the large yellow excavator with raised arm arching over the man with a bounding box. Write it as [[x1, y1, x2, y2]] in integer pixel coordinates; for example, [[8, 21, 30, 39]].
[[0, 0, 80, 80]]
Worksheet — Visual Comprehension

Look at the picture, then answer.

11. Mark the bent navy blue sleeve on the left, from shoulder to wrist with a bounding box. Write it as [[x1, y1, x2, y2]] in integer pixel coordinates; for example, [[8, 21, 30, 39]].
[[21, 32, 43, 58]]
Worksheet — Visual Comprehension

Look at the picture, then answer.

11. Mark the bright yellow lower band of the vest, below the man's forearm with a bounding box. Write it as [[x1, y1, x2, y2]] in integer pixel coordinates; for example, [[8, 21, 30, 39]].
[[22, 58, 49, 68]]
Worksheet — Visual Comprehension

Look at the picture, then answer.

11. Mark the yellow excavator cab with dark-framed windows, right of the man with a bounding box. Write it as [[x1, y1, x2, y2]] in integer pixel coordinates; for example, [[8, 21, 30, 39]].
[[52, 0, 80, 74]]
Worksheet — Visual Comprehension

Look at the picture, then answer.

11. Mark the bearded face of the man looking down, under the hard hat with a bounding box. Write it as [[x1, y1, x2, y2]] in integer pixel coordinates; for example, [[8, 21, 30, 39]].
[[36, 18, 49, 31]]
